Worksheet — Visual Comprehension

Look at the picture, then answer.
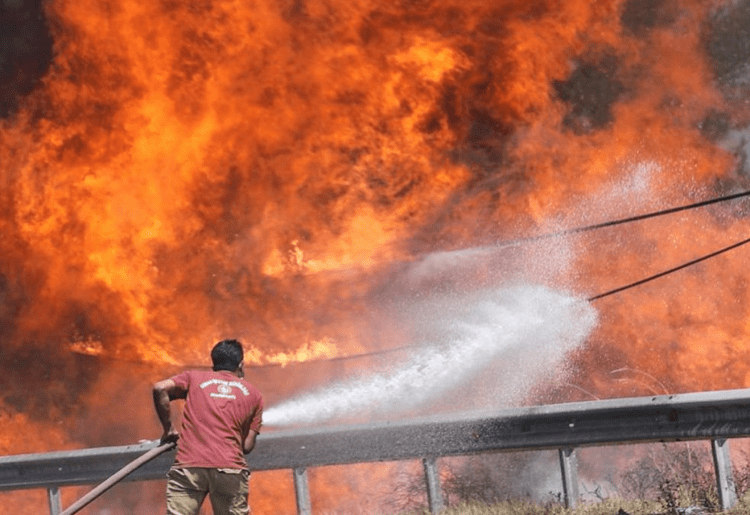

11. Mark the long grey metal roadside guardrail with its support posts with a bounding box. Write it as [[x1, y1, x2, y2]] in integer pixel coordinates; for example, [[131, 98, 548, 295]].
[[0, 390, 750, 515]]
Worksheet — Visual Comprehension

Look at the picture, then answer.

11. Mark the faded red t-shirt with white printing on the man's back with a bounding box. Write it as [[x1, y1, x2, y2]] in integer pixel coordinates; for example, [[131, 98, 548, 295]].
[[171, 370, 263, 469]]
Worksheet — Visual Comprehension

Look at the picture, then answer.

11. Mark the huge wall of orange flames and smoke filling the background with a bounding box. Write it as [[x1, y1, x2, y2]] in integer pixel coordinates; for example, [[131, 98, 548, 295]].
[[0, 0, 750, 514]]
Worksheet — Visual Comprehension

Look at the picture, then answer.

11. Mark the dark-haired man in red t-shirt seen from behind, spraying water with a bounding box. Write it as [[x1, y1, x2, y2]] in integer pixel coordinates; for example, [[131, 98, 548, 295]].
[[153, 340, 263, 515]]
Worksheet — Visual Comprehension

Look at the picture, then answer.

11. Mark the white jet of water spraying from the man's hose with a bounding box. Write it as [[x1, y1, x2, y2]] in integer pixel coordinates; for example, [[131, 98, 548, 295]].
[[264, 285, 596, 426]]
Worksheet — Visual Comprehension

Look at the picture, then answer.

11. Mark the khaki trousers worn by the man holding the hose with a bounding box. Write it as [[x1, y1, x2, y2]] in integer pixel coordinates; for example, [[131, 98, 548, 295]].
[[167, 467, 250, 515]]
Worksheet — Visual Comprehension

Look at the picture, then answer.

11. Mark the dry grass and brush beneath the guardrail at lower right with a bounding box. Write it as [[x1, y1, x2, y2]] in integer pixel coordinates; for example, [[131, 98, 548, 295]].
[[382, 444, 750, 515]]
